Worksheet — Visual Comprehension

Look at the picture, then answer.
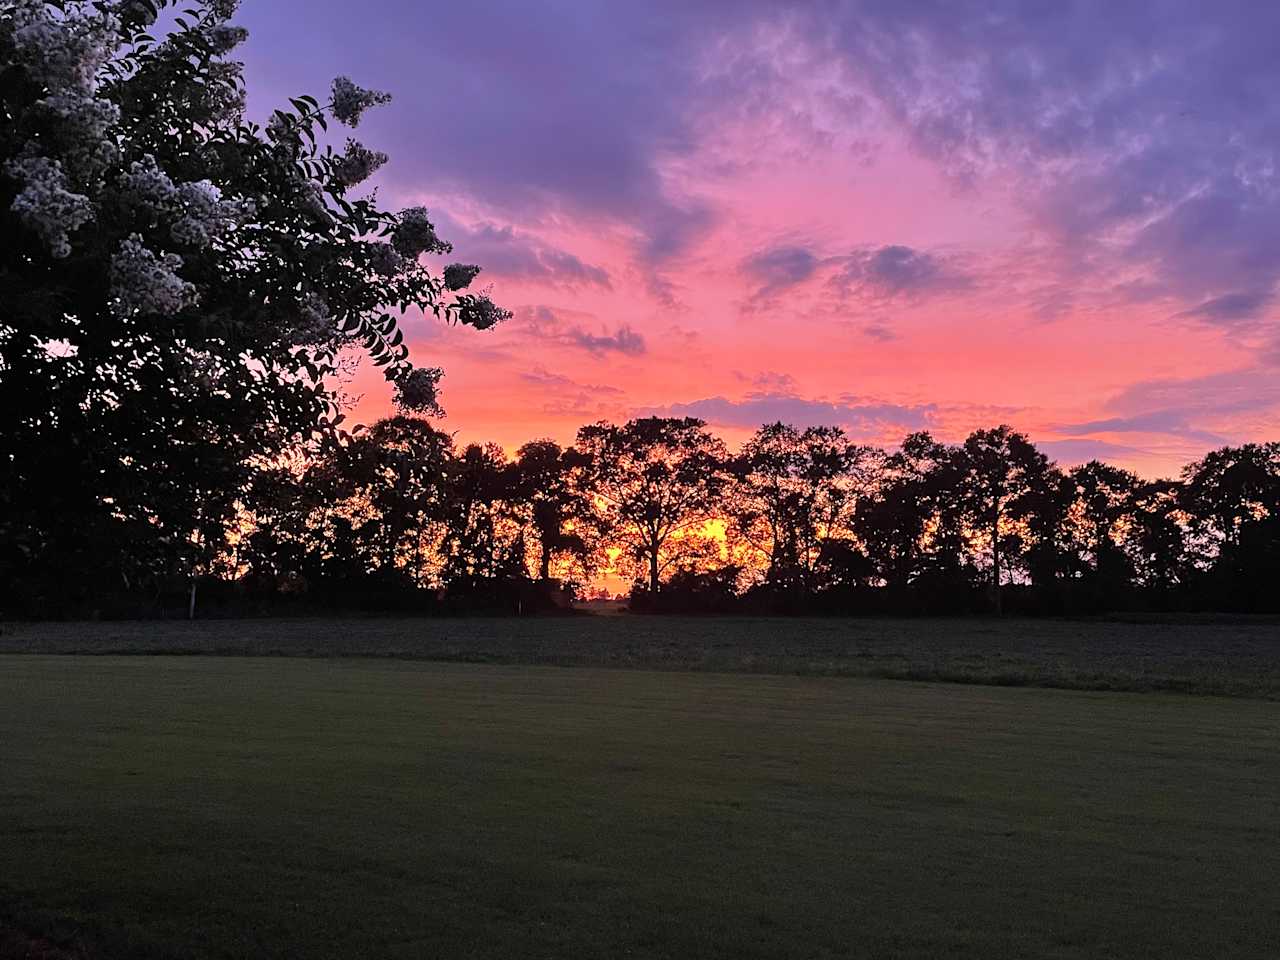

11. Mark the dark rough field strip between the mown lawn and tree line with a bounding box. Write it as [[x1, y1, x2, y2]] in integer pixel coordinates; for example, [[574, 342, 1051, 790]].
[[0, 616, 1280, 700]]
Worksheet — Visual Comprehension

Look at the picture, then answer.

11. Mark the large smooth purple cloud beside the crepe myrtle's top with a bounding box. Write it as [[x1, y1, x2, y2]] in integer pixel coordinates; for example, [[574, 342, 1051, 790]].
[[241, 0, 747, 271]]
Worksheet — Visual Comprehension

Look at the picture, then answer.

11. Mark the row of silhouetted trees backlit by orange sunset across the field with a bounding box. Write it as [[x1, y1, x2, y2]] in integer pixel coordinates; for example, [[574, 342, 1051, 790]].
[[4, 416, 1280, 616]]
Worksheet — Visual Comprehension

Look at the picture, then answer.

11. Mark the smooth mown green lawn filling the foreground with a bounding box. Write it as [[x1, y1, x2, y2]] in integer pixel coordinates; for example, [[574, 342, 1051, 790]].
[[0, 655, 1280, 960]]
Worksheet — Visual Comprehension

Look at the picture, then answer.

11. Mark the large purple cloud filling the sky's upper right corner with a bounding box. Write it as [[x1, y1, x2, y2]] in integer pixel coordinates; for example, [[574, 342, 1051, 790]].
[[831, 0, 1280, 321]]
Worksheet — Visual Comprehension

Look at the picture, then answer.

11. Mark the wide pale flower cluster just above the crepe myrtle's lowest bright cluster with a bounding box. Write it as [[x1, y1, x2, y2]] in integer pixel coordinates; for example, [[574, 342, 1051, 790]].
[[120, 154, 255, 247]]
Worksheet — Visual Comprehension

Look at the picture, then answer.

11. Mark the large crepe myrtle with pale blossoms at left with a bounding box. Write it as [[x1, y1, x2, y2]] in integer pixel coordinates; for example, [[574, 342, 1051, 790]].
[[0, 0, 508, 603]]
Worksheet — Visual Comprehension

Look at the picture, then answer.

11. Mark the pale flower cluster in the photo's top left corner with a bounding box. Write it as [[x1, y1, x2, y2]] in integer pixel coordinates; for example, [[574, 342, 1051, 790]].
[[10, 0, 120, 93]]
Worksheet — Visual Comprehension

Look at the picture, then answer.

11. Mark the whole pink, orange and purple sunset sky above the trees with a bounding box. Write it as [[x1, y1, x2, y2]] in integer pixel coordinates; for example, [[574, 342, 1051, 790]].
[[238, 0, 1280, 476]]
